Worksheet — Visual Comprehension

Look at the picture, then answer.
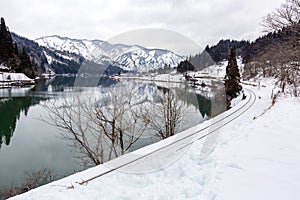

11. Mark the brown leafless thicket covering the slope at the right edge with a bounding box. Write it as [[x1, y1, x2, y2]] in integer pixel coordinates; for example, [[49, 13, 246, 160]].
[[244, 41, 300, 96]]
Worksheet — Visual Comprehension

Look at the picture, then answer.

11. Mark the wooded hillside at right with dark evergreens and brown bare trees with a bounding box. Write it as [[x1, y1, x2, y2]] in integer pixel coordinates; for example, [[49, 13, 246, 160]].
[[205, 0, 300, 96]]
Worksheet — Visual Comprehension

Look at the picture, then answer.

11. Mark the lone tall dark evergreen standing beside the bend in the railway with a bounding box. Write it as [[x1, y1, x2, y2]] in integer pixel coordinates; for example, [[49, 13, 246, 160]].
[[225, 48, 242, 109]]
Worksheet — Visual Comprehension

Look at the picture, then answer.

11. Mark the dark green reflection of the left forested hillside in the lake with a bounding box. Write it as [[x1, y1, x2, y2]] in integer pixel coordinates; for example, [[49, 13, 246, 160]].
[[0, 76, 115, 148]]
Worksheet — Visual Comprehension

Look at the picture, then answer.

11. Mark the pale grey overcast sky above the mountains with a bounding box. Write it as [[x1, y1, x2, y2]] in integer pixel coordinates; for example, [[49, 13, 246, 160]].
[[0, 0, 284, 53]]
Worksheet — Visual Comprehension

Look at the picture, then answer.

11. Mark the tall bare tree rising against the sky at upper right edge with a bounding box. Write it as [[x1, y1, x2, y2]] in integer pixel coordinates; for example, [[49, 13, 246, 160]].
[[254, 0, 300, 96]]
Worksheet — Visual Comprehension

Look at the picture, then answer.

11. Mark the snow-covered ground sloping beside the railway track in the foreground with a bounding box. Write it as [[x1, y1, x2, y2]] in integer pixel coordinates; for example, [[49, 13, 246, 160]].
[[12, 81, 300, 200]]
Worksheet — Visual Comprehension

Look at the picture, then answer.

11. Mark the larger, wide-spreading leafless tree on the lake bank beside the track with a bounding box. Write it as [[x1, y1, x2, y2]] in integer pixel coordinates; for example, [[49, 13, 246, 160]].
[[43, 87, 145, 166]]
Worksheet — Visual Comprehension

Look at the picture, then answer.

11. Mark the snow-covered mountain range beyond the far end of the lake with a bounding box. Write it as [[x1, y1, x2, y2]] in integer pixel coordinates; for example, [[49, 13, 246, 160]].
[[35, 36, 184, 72]]
